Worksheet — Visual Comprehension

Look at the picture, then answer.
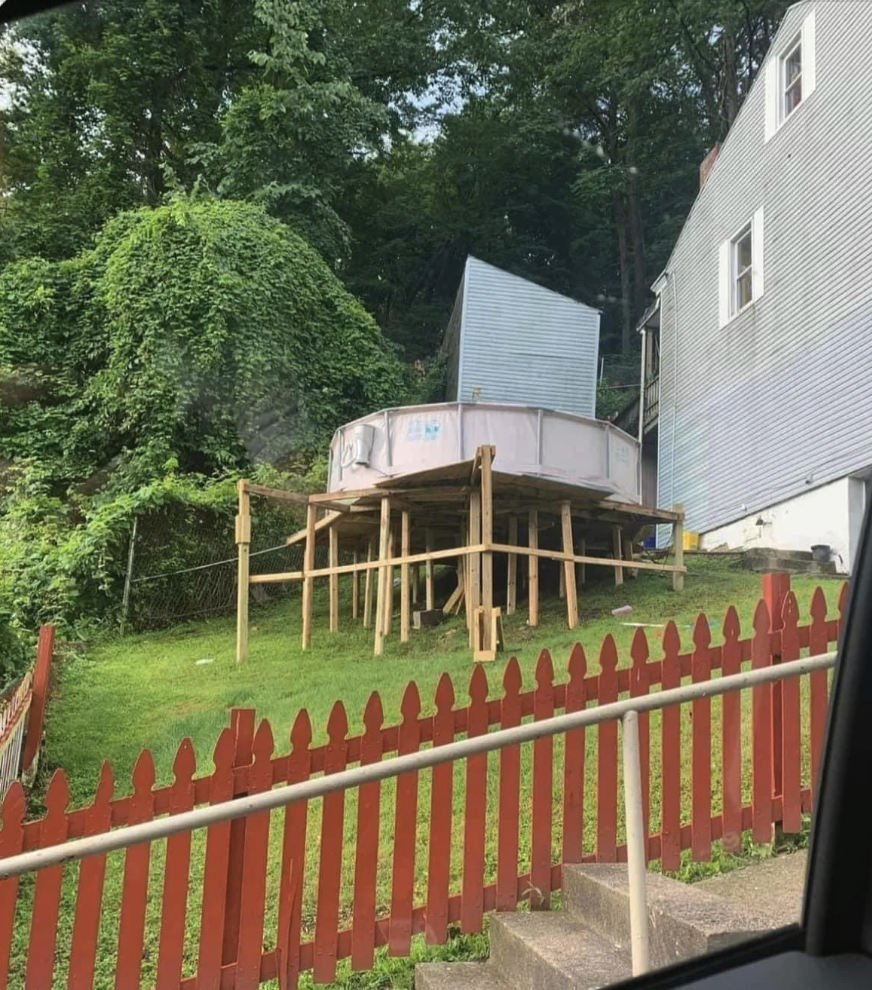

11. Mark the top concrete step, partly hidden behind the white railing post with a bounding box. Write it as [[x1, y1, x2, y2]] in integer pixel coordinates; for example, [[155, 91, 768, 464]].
[[563, 863, 775, 967]]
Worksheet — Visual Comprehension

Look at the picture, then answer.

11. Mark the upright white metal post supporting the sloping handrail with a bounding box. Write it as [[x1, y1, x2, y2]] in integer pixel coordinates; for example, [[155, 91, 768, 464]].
[[621, 712, 650, 976]]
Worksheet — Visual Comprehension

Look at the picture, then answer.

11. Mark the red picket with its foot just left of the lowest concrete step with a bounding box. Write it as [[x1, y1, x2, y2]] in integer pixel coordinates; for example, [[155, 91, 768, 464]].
[[388, 681, 421, 956]]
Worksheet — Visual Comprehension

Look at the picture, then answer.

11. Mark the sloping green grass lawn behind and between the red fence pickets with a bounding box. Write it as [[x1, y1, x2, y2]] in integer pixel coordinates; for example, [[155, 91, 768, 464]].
[[10, 557, 840, 988]]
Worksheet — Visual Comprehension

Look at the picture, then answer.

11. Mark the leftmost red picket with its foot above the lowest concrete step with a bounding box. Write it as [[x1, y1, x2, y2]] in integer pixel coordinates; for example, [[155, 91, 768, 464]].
[[428, 674, 454, 945]]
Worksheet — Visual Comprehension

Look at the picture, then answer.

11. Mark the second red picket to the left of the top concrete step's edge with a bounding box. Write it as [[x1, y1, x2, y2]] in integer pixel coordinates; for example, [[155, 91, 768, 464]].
[[496, 657, 522, 911]]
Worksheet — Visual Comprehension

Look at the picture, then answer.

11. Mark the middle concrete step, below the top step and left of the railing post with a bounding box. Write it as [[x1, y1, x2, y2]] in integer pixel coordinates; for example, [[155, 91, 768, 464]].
[[490, 911, 632, 990]]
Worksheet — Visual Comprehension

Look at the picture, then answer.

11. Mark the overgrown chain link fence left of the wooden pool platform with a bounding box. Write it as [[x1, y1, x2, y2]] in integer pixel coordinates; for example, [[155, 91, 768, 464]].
[[123, 500, 328, 632]]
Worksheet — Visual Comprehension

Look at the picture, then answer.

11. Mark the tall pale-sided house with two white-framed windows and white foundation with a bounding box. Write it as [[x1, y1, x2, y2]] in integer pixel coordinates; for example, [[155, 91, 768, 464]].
[[657, 0, 872, 570]]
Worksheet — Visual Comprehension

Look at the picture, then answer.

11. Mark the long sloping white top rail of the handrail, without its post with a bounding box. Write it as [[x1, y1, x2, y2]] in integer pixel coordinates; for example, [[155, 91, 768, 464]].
[[0, 653, 836, 880]]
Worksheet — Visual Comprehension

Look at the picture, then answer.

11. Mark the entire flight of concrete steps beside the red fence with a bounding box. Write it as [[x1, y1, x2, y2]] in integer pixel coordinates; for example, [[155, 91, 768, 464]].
[[415, 864, 773, 990]]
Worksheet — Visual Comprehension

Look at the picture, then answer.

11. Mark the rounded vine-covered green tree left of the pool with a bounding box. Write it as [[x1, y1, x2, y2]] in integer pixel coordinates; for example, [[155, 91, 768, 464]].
[[0, 198, 404, 484]]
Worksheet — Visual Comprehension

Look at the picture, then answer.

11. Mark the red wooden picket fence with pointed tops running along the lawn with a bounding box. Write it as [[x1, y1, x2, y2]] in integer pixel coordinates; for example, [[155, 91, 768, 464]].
[[0, 581, 845, 990]]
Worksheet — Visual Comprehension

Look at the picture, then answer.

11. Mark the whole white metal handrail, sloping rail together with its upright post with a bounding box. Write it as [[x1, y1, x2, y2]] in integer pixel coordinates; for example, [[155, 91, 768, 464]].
[[0, 652, 837, 974]]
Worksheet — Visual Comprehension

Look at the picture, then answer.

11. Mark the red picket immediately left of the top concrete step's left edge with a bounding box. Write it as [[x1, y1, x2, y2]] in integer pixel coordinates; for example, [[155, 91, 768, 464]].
[[530, 650, 556, 911]]
